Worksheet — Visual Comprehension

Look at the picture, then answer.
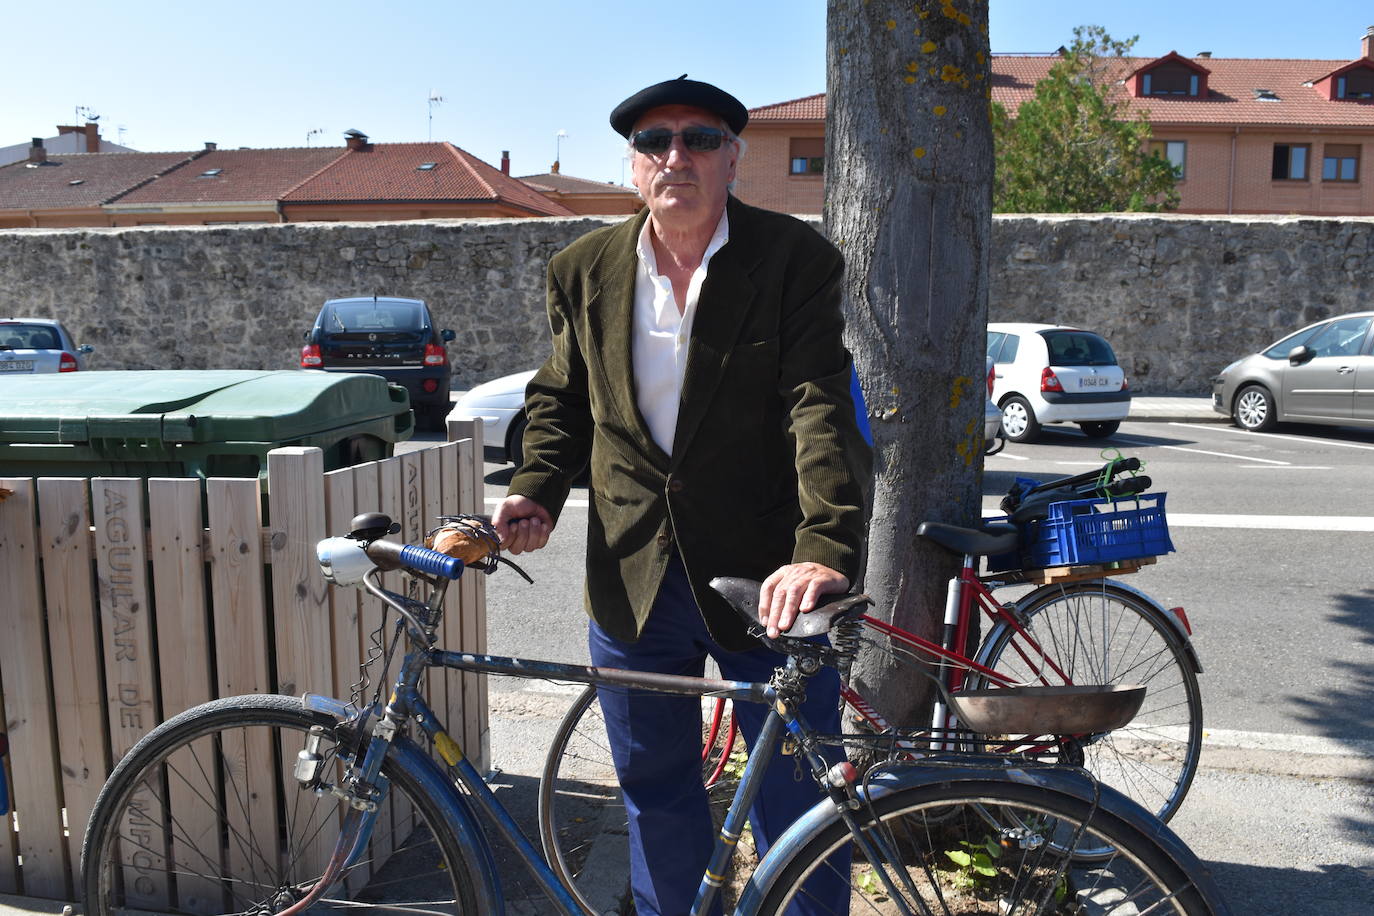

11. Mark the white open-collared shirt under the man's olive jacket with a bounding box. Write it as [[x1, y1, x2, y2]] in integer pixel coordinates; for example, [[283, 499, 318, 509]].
[[631, 213, 730, 455]]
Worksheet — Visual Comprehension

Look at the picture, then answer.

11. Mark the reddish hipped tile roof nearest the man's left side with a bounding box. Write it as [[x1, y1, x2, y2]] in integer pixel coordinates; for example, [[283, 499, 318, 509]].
[[282, 143, 573, 216]]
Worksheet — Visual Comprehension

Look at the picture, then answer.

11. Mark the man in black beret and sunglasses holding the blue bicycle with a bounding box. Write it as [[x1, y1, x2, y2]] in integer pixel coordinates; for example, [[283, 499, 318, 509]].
[[493, 77, 870, 916]]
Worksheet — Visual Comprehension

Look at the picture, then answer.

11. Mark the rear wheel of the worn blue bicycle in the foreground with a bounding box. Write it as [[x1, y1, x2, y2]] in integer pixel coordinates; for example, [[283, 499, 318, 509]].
[[742, 779, 1224, 916]]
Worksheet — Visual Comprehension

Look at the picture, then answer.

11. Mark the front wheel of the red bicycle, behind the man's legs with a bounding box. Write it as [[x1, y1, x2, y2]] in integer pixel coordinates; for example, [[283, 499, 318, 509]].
[[539, 685, 742, 916]]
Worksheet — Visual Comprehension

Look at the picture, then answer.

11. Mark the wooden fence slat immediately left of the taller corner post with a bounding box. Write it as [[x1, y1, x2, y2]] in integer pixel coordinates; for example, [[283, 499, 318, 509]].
[[205, 478, 280, 880]]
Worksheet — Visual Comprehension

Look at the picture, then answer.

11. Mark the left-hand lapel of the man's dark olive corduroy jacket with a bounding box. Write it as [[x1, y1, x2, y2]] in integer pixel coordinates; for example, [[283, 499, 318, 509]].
[[587, 207, 668, 470]]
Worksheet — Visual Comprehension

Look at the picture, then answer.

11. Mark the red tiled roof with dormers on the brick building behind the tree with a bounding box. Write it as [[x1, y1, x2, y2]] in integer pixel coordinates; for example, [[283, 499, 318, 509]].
[[746, 54, 1374, 130]]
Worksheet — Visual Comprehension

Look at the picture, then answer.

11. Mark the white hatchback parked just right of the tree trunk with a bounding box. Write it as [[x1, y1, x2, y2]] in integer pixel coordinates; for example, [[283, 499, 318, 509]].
[[988, 321, 1131, 442]]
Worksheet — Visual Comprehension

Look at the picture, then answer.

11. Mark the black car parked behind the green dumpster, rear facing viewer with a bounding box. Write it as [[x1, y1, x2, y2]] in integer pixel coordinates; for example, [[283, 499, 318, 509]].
[[301, 295, 453, 430]]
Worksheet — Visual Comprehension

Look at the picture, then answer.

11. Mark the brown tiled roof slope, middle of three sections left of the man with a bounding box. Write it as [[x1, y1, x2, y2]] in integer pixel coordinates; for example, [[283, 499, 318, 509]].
[[118, 147, 348, 203]]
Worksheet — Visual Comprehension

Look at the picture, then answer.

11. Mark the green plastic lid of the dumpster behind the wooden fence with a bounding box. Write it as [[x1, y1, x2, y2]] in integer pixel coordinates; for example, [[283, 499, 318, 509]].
[[0, 369, 409, 444]]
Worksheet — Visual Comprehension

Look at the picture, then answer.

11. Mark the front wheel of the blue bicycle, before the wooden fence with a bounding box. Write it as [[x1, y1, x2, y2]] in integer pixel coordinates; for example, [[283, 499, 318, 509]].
[[81, 695, 484, 916]]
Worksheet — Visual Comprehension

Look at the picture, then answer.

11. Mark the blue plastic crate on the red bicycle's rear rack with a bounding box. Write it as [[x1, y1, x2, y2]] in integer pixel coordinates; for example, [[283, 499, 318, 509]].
[[988, 493, 1173, 573]]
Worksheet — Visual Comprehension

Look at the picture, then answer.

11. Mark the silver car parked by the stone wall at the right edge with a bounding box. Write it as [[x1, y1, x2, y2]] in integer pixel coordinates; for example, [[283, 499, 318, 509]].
[[1212, 312, 1374, 431]]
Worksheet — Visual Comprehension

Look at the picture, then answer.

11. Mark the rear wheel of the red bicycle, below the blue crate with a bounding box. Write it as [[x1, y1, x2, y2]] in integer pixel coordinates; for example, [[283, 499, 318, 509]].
[[967, 581, 1202, 857]]
